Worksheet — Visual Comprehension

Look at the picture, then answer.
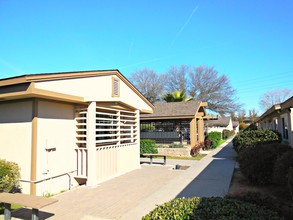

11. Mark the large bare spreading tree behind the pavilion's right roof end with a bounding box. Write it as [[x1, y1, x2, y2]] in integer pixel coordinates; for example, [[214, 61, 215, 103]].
[[189, 66, 241, 115]]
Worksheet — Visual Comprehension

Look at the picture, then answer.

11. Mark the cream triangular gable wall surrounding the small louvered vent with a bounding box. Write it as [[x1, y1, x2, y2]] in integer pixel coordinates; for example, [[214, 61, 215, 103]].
[[35, 74, 151, 110]]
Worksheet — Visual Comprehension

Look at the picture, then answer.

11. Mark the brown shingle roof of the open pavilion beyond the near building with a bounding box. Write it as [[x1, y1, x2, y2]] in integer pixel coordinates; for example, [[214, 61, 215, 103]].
[[140, 101, 201, 119]]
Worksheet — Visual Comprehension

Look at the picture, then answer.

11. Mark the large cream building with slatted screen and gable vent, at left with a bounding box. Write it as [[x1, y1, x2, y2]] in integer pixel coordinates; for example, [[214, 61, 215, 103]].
[[0, 70, 154, 195]]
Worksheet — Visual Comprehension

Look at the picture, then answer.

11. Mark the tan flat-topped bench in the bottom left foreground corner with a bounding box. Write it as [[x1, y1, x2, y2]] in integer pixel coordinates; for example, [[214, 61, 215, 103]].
[[0, 193, 58, 220]]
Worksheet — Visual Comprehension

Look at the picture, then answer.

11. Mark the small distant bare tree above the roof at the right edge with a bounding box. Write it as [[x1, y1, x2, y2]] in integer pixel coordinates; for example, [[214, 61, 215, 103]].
[[259, 89, 292, 110]]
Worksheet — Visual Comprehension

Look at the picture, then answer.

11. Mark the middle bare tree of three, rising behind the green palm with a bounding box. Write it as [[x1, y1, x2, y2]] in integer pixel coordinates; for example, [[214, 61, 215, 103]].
[[164, 65, 189, 93]]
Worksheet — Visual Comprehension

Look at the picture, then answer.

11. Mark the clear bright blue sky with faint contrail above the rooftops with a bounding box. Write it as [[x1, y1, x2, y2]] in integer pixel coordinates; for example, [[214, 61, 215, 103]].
[[0, 0, 293, 114]]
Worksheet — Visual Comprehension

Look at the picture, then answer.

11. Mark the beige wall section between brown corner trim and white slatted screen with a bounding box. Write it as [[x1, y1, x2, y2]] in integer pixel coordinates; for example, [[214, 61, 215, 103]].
[[36, 101, 77, 195]]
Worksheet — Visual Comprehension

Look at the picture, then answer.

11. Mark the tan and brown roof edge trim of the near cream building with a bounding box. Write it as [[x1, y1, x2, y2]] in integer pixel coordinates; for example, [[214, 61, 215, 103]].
[[0, 69, 154, 112]]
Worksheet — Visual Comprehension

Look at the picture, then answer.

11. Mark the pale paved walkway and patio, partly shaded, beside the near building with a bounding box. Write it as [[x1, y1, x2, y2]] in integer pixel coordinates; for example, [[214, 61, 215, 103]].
[[9, 139, 236, 220]]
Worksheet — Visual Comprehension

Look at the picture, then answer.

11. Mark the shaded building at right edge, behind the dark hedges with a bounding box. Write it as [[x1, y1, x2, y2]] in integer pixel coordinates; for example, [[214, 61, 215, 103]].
[[255, 96, 293, 147]]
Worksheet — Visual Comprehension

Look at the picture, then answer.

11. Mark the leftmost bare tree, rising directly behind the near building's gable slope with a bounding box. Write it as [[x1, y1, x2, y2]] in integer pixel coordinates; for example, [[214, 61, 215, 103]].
[[129, 68, 165, 103]]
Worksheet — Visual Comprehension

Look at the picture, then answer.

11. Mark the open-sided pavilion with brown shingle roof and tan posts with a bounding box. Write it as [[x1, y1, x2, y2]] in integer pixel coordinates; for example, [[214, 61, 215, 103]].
[[140, 101, 207, 146]]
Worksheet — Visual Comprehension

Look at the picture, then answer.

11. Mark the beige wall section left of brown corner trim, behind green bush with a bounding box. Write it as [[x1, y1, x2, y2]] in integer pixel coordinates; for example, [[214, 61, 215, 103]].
[[0, 101, 32, 193]]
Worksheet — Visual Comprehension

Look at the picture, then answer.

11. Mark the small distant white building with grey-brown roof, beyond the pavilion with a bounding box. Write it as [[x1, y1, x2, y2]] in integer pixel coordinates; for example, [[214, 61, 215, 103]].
[[205, 116, 234, 133]]
